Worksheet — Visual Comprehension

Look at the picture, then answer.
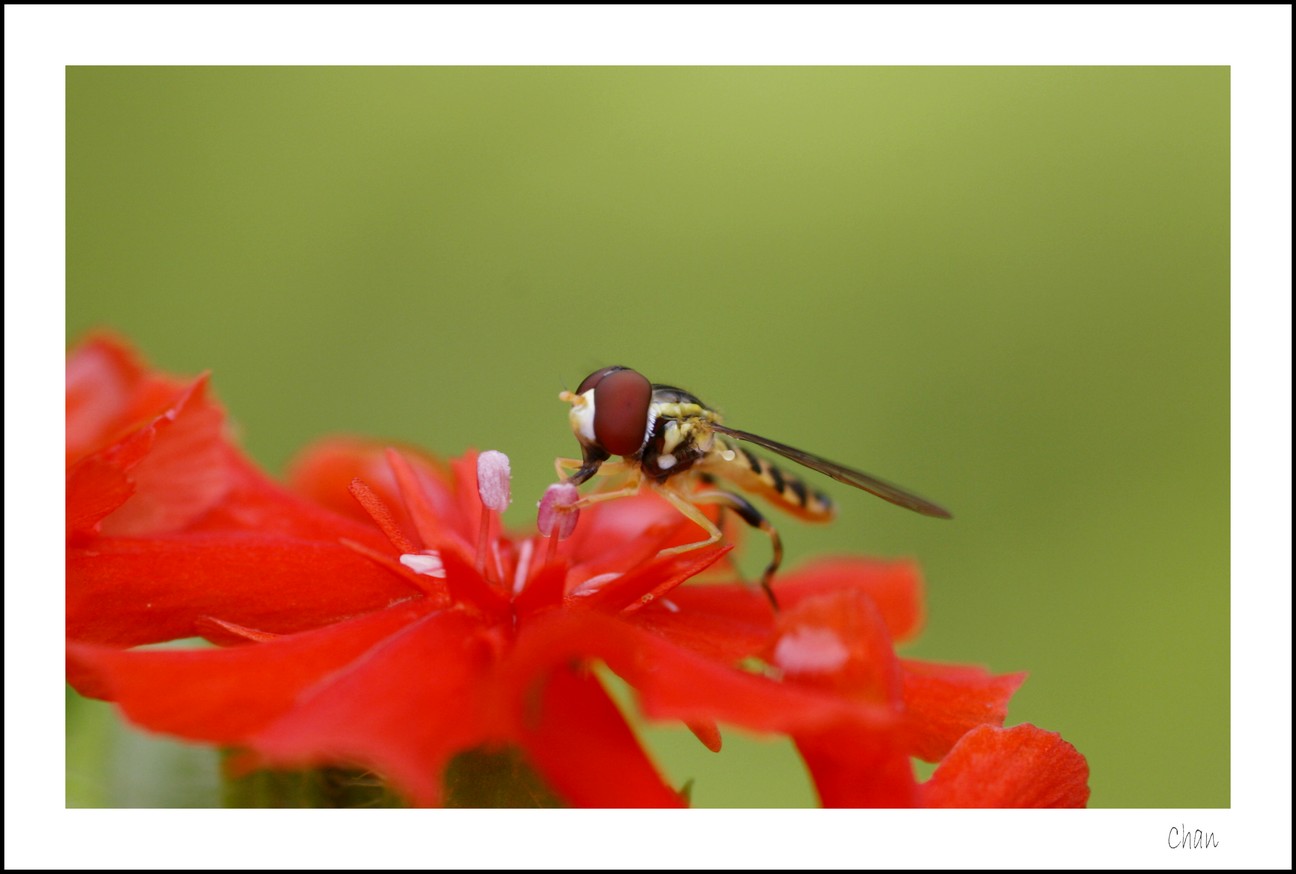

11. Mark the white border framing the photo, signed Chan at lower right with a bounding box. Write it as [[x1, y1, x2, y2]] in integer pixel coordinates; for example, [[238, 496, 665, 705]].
[[4, 5, 1292, 868]]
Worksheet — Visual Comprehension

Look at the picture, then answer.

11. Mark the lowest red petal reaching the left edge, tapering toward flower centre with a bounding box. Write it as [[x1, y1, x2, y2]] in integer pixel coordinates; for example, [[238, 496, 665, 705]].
[[67, 604, 422, 726]]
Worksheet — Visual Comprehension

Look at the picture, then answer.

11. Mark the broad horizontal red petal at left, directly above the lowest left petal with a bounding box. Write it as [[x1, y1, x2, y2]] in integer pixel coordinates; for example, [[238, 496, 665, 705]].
[[67, 526, 420, 646]]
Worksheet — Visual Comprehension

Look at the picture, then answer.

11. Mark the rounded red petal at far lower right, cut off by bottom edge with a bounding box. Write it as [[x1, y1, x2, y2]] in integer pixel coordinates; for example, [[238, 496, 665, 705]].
[[921, 725, 1089, 808]]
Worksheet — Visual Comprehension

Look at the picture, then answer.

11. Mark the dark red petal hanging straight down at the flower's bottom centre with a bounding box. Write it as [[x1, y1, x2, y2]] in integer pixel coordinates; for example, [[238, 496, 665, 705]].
[[522, 667, 683, 808]]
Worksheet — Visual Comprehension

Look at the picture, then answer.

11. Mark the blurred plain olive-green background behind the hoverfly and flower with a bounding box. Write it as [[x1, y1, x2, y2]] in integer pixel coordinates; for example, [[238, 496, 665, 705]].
[[67, 67, 1230, 808]]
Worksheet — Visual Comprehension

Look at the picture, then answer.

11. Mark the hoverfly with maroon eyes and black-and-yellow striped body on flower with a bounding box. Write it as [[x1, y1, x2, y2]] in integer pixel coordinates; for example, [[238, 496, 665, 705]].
[[555, 367, 951, 609]]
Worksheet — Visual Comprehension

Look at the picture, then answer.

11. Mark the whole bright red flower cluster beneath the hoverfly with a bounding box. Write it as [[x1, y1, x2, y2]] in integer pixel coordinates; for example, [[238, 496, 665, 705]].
[[67, 338, 1087, 807]]
